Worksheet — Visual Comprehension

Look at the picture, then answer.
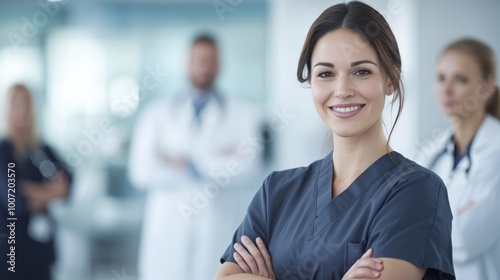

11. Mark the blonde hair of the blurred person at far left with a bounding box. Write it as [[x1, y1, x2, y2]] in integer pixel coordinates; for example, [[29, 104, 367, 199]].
[[6, 83, 40, 155]]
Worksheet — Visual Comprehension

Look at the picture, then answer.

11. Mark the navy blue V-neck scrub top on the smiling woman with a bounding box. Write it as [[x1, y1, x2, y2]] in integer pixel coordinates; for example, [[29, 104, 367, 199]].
[[221, 152, 455, 280]]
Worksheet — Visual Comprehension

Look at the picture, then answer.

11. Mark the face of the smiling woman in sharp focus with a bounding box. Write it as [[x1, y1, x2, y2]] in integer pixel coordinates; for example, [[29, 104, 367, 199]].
[[310, 29, 393, 137]]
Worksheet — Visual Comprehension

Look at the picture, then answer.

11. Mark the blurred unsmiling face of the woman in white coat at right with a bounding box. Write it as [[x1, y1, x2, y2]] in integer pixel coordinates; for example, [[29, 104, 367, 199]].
[[434, 50, 489, 118]]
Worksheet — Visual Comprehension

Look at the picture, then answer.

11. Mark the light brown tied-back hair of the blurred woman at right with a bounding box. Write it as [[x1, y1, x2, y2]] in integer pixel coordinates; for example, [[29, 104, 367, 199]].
[[442, 38, 500, 118]]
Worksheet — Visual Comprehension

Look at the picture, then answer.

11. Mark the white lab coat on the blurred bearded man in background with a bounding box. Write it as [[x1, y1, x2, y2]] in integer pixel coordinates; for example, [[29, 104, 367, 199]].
[[129, 92, 262, 280]]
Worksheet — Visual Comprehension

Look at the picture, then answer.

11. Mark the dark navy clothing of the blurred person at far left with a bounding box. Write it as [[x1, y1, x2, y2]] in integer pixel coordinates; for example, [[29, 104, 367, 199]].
[[0, 139, 71, 280]]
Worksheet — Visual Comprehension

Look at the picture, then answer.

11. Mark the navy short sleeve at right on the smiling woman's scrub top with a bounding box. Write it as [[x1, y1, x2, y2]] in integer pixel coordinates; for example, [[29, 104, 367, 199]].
[[367, 171, 455, 279]]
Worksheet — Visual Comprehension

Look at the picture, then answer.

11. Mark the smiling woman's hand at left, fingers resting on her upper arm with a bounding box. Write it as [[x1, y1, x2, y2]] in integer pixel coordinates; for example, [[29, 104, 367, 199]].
[[233, 235, 276, 279]]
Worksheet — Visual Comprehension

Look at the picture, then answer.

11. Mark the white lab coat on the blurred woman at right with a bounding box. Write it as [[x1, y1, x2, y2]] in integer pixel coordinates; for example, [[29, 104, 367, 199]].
[[415, 115, 500, 280]]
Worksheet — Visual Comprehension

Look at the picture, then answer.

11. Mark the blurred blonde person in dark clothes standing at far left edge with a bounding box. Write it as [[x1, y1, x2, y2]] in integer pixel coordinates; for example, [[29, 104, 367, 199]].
[[0, 84, 71, 280]]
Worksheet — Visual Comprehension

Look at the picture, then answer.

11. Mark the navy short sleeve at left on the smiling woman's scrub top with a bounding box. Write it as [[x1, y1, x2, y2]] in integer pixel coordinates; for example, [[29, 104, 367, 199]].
[[220, 174, 272, 263]]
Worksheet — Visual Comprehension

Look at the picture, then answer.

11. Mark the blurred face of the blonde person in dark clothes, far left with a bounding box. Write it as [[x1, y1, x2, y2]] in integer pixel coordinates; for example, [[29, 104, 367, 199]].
[[10, 89, 32, 129]]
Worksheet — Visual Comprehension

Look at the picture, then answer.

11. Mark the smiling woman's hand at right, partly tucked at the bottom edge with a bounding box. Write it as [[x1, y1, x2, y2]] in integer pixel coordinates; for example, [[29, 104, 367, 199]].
[[342, 248, 384, 280]]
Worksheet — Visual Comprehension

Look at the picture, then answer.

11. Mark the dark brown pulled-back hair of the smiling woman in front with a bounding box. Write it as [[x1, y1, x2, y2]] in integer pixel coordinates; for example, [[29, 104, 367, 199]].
[[297, 1, 404, 147]]
